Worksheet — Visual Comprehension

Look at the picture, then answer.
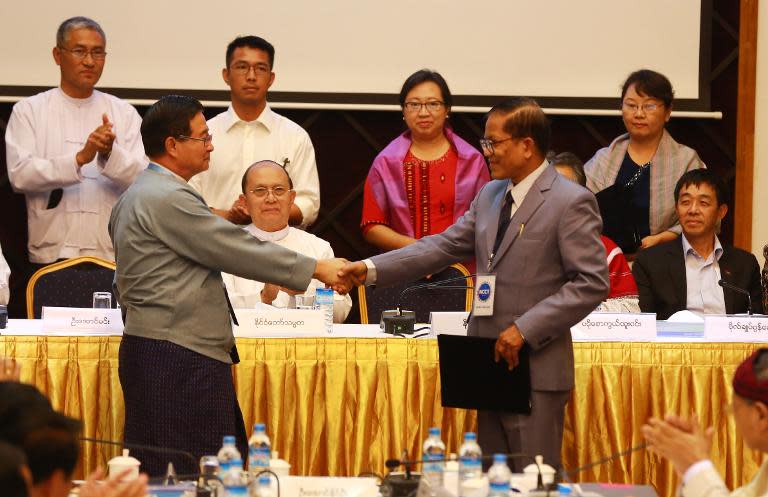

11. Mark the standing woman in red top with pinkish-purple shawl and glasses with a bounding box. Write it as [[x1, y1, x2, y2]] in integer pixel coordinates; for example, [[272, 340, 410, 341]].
[[360, 69, 490, 260]]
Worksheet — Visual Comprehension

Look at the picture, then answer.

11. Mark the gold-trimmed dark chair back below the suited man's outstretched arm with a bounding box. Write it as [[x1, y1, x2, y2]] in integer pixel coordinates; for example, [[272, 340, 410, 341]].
[[357, 264, 473, 324]]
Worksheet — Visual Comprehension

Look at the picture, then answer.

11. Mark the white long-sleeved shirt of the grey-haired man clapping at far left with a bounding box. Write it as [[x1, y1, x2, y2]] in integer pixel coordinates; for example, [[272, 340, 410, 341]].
[[5, 88, 149, 263]]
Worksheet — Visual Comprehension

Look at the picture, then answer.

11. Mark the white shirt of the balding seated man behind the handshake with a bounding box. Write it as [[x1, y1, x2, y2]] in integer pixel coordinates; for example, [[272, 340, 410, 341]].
[[221, 224, 352, 323]]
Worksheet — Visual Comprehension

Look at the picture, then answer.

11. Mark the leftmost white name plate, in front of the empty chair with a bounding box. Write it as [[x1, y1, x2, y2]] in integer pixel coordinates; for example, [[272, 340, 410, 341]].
[[42, 307, 124, 335]]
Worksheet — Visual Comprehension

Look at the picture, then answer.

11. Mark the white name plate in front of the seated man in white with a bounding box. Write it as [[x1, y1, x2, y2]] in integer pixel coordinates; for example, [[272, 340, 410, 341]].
[[234, 308, 328, 338]]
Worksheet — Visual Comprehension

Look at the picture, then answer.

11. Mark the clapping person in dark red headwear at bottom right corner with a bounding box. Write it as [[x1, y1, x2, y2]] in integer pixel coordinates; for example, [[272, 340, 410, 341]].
[[643, 348, 768, 497]]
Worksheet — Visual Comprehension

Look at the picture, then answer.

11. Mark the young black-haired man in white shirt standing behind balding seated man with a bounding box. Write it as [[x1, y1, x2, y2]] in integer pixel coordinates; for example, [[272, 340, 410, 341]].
[[190, 36, 320, 227]]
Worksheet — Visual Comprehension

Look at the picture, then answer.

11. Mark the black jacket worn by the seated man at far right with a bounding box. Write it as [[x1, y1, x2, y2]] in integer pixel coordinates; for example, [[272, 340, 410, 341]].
[[632, 237, 763, 319]]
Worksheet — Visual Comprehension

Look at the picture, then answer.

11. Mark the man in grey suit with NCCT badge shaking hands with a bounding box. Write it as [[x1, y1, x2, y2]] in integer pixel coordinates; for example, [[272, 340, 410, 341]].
[[341, 98, 608, 470]]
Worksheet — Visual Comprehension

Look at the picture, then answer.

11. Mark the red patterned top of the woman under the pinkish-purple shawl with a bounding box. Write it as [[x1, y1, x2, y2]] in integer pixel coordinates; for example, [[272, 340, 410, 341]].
[[361, 147, 459, 239]]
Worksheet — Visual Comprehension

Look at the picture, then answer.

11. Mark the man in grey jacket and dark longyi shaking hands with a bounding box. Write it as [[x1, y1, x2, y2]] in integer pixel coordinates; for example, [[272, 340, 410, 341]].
[[109, 95, 343, 475]]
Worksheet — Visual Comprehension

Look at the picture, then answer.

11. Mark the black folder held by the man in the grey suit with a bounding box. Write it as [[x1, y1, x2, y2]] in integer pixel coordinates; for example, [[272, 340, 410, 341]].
[[437, 335, 531, 414]]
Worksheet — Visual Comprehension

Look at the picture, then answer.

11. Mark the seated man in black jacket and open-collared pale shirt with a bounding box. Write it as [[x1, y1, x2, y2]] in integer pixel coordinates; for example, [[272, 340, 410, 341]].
[[632, 169, 763, 319]]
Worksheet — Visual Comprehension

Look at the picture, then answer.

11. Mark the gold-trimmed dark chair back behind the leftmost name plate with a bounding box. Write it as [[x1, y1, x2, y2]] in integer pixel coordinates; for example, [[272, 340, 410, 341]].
[[27, 257, 117, 319]]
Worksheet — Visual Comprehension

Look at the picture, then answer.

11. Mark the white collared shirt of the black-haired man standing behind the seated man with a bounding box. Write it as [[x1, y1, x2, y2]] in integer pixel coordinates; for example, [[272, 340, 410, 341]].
[[189, 106, 320, 227]]
